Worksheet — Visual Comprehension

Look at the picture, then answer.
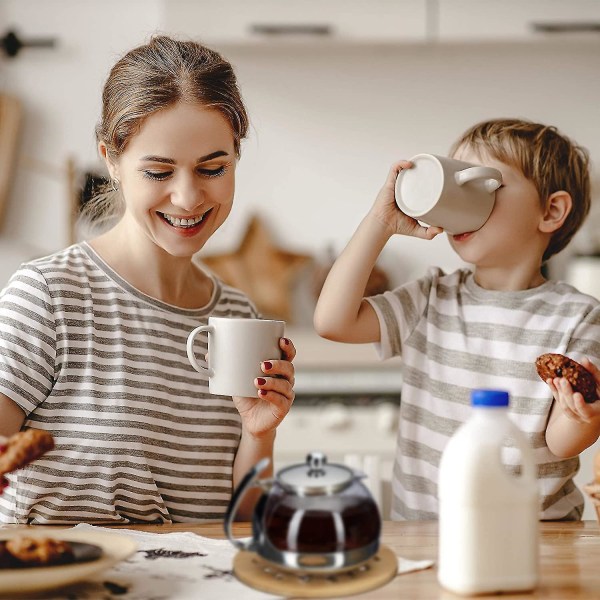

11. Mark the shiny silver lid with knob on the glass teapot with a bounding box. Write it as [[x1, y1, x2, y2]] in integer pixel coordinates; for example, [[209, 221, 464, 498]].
[[277, 452, 356, 496]]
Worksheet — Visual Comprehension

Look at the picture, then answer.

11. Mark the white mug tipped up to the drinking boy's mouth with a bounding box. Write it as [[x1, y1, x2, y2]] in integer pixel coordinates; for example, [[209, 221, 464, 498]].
[[396, 154, 502, 234]]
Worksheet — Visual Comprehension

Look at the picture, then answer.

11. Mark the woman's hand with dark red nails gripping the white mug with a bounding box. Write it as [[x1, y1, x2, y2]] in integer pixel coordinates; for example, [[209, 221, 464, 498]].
[[233, 338, 296, 438]]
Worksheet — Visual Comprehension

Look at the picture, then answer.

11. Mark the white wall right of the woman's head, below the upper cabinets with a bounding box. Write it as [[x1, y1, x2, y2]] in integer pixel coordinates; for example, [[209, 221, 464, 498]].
[[227, 44, 600, 284]]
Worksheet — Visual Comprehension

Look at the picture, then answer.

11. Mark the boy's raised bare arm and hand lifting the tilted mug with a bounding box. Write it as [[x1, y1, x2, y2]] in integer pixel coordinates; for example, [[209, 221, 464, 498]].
[[314, 161, 442, 343]]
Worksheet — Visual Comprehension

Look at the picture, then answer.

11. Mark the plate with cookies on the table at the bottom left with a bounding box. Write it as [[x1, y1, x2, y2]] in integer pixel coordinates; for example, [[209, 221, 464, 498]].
[[0, 526, 136, 597]]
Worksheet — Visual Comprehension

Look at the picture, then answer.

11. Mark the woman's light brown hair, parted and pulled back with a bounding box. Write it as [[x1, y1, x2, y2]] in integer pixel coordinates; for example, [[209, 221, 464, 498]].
[[82, 35, 249, 228]]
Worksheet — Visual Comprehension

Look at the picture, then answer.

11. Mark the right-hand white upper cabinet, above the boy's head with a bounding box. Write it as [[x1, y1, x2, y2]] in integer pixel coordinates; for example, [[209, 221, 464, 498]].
[[431, 0, 600, 42]]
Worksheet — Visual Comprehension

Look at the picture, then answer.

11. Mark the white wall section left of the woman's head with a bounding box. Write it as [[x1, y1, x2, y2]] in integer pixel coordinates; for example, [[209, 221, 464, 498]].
[[0, 0, 159, 278]]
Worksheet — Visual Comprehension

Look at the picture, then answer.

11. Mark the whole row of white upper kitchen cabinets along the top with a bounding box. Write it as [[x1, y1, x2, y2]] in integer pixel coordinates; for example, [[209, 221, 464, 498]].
[[160, 0, 600, 46]]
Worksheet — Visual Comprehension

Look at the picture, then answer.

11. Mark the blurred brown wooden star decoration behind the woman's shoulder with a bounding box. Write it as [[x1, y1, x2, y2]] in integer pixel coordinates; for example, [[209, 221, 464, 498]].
[[201, 216, 312, 322]]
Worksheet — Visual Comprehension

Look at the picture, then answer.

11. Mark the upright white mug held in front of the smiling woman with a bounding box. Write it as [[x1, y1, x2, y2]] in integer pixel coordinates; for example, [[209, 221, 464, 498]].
[[187, 317, 285, 397]]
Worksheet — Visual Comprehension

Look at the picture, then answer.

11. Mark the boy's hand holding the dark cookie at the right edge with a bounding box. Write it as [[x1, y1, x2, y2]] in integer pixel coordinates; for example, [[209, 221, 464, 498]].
[[546, 358, 600, 458]]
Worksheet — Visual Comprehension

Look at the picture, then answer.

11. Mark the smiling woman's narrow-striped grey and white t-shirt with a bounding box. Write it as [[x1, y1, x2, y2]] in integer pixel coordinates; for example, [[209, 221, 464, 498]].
[[0, 243, 257, 523]]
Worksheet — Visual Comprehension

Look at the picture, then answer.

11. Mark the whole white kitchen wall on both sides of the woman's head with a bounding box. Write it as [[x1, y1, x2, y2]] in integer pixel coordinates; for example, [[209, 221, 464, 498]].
[[0, 0, 600, 290]]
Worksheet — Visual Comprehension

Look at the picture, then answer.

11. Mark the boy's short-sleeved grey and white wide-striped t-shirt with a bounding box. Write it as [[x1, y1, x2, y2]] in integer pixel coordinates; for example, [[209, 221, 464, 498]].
[[369, 269, 600, 520]]
